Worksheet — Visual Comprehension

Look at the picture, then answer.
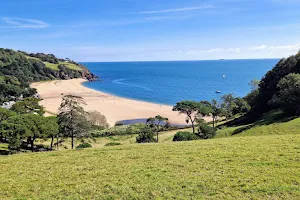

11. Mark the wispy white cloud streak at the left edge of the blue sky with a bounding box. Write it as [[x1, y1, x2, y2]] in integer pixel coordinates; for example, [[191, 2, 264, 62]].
[[0, 17, 49, 29]]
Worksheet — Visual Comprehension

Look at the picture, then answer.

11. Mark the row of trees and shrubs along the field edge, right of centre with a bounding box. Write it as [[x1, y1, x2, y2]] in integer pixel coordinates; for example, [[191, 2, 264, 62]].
[[136, 94, 250, 143]]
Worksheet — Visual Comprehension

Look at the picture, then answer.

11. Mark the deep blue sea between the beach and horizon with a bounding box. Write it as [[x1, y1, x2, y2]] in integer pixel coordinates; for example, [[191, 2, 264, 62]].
[[83, 59, 279, 105]]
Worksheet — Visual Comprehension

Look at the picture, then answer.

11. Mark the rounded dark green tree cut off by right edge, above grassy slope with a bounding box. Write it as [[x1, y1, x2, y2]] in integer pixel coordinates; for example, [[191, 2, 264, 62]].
[[269, 73, 300, 115]]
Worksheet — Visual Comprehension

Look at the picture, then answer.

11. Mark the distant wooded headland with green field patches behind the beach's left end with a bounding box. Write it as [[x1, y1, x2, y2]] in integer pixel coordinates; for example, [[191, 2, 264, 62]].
[[0, 48, 97, 103]]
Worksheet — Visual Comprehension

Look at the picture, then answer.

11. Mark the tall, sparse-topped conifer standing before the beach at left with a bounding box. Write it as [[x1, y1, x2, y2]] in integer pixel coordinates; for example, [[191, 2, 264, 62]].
[[58, 95, 91, 149]]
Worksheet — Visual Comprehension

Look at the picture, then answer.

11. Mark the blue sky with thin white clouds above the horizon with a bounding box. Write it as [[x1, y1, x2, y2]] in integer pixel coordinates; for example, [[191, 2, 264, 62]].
[[0, 0, 300, 61]]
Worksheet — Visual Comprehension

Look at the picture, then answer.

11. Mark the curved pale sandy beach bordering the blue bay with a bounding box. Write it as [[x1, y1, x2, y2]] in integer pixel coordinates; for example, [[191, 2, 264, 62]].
[[31, 79, 209, 126]]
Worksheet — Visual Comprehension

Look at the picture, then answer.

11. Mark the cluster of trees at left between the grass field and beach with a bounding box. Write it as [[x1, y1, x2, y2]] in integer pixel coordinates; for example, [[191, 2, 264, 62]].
[[0, 95, 108, 152]]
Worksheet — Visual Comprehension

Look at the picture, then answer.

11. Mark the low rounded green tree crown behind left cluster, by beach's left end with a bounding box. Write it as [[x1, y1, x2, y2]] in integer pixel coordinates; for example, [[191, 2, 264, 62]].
[[11, 97, 45, 115]]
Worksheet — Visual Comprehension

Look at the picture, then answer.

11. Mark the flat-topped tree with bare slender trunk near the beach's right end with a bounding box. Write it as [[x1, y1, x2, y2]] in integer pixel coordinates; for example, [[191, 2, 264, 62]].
[[173, 101, 199, 133]]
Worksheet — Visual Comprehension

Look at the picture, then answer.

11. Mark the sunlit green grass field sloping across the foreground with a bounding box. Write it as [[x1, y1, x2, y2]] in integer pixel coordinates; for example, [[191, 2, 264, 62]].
[[0, 135, 300, 199]]
